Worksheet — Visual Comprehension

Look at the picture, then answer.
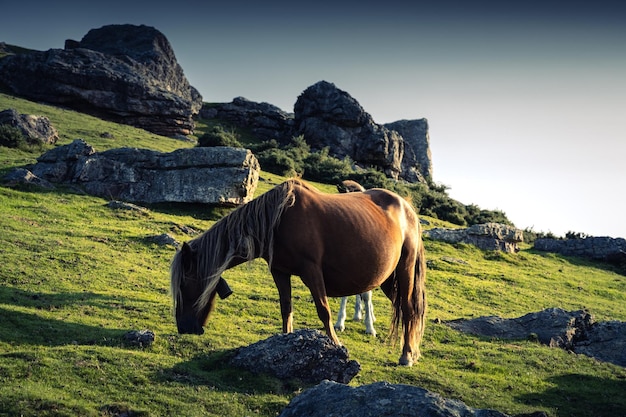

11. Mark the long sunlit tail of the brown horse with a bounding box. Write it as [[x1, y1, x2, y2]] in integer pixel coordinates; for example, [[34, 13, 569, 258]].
[[390, 230, 427, 360]]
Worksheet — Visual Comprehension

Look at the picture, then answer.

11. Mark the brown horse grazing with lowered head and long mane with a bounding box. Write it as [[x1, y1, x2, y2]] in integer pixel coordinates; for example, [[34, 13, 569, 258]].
[[171, 180, 426, 366]]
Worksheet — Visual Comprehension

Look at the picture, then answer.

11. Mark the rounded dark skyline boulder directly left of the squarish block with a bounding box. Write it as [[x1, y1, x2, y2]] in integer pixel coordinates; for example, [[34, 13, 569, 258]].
[[294, 81, 404, 178]]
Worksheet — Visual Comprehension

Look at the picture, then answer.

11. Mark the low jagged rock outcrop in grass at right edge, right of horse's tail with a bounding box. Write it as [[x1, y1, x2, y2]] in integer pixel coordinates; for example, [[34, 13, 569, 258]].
[[446, 308, 626, 366]]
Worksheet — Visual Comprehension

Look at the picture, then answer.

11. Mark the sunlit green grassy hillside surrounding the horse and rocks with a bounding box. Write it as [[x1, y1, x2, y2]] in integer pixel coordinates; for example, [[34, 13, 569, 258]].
[[0, 95, 626, 416]]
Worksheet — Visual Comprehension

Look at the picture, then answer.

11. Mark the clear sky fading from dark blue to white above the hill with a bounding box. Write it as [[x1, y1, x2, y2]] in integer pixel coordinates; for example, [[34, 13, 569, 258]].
[[0, 0, 626, 237]]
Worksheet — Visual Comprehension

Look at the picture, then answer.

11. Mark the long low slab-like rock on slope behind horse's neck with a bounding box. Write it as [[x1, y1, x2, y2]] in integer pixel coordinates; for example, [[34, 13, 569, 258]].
[[4, 140, 260, 205]]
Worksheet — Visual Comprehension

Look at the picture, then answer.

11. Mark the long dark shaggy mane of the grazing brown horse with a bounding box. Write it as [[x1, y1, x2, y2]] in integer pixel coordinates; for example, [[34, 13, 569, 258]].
[[170, 179, 300, 310]]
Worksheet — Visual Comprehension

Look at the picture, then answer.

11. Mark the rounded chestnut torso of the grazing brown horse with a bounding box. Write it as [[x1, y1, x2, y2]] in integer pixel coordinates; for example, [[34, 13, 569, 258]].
[[274, 182, 410, 296]]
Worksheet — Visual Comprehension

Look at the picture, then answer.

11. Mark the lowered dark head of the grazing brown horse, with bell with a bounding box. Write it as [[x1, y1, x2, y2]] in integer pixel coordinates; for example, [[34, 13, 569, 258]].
[[171, 243, 232, 334]]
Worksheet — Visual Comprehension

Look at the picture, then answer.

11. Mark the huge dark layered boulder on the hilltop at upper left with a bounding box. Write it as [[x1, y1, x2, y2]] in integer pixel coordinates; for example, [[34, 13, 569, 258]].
[[0, 25, 202, 136]]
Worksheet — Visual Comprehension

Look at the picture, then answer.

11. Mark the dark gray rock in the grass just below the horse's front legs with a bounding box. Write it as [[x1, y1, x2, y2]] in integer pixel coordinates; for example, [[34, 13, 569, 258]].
[[231, 329, 361, 384]]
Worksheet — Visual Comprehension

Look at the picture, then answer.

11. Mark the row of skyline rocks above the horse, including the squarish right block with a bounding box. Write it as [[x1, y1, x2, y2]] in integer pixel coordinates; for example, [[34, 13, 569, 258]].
[[201, 81, 433, 182]]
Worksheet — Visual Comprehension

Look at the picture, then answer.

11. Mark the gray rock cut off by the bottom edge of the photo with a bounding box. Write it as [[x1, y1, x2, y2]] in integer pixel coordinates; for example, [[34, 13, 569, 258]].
[[280, 381, 507, 417]]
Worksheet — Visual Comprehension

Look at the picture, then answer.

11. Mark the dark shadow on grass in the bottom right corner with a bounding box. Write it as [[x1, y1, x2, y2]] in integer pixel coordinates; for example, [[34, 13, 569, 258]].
[[518, 374, 626, 417]]
